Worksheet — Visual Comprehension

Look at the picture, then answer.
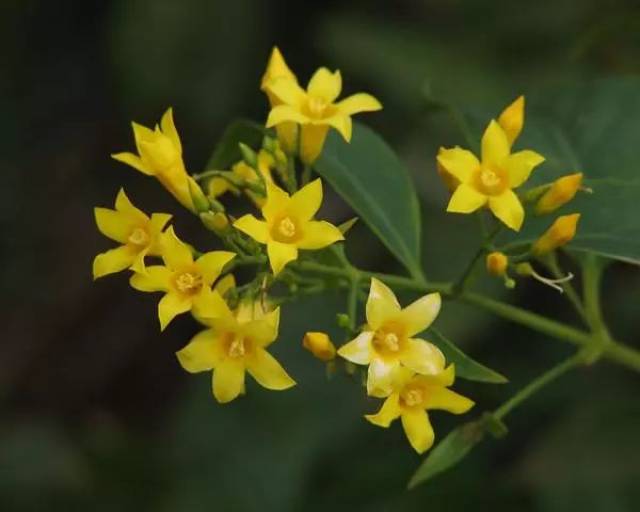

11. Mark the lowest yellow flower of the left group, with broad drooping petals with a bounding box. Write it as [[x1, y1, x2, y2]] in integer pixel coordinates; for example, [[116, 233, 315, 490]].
[[176, 303, 295, 403]]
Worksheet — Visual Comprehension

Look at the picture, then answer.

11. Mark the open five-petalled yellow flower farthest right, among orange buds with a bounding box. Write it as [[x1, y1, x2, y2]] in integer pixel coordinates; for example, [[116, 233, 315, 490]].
[[437, 121, 544, 231]]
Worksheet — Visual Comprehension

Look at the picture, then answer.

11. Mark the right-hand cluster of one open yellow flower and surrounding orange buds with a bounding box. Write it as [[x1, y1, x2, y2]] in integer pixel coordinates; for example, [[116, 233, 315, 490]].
[[437, 96, 588, 287]]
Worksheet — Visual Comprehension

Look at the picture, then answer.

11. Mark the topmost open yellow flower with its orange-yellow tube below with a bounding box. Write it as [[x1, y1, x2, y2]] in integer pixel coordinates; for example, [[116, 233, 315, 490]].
[[267, 68, 382, 164]]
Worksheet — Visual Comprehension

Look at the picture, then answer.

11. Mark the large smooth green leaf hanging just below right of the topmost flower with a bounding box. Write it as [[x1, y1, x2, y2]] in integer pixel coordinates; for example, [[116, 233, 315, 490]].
[[314, 123, 422, 278]]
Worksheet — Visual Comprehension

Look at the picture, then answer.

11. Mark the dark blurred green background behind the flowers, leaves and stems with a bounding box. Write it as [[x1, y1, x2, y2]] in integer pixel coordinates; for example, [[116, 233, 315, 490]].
[[0, 0, 640, 512]]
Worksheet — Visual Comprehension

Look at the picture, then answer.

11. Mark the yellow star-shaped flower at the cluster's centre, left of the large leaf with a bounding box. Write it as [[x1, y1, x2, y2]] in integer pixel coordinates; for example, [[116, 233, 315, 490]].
[[233, 178, 344, 275]]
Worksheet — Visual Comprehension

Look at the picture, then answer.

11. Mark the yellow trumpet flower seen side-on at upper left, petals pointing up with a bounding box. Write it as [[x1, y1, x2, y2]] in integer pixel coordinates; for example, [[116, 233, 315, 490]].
[[111, 109, 202, 211]]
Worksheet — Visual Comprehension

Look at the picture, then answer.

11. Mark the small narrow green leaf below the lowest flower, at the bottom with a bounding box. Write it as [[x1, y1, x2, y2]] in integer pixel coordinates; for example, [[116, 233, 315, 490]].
[[408, 421, 484, 489]]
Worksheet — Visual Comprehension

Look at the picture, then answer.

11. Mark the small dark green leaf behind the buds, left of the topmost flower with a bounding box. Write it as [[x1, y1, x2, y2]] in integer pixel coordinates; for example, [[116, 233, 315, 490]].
[[205, 119, 268, 170]]
